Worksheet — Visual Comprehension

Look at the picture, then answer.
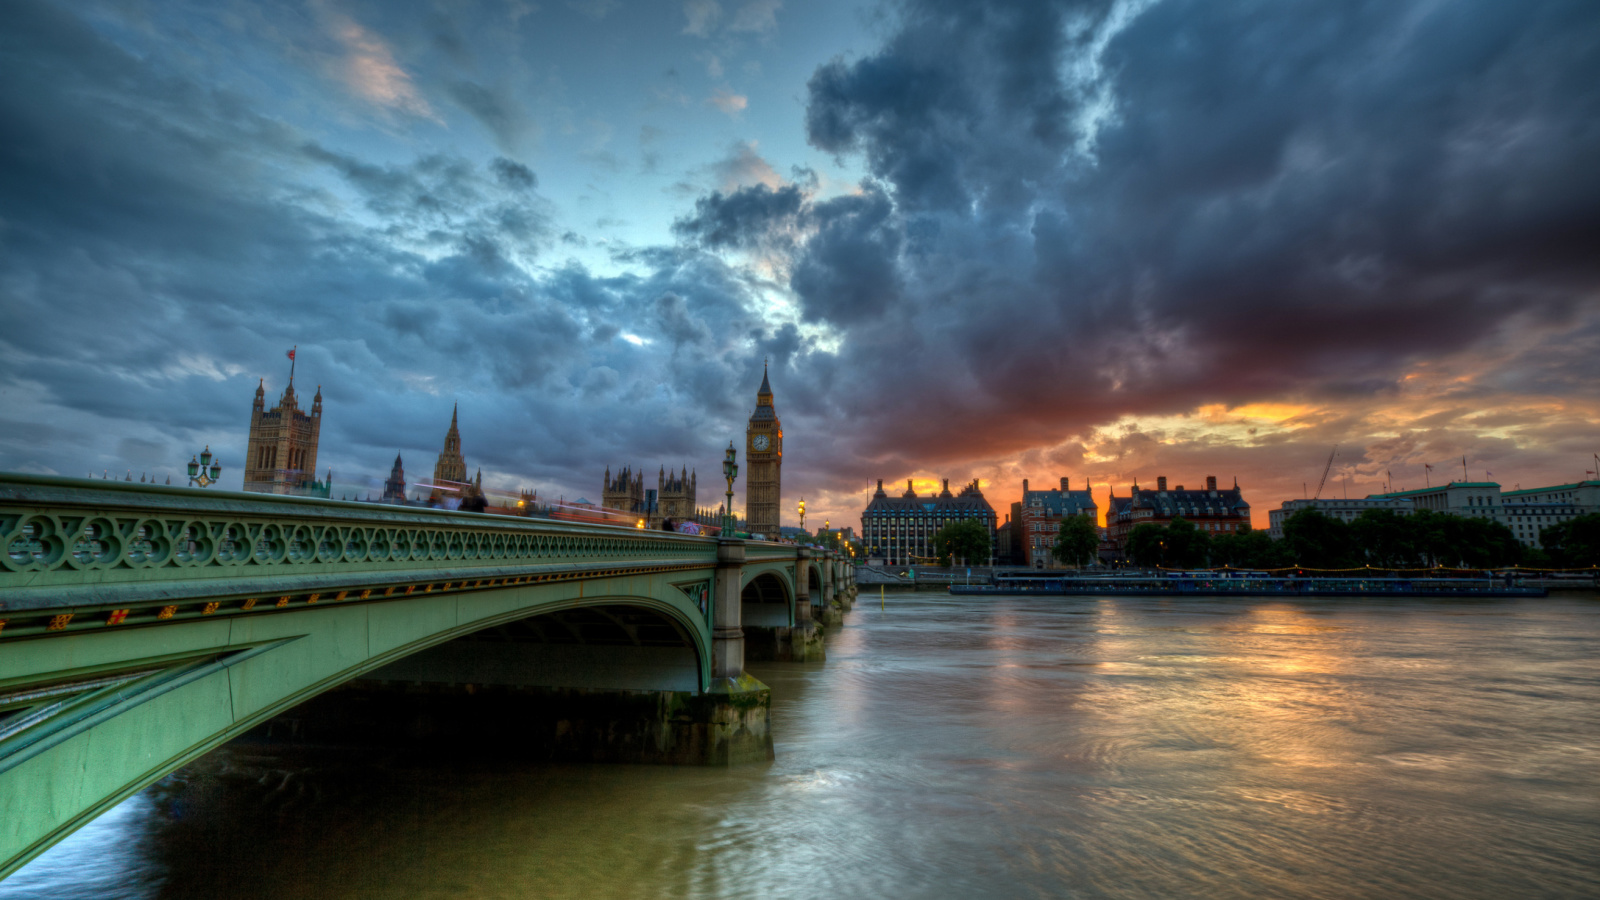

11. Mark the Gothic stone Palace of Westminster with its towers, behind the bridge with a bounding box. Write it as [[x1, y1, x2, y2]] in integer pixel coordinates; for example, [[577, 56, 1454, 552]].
[[233, 360, 784, 536]]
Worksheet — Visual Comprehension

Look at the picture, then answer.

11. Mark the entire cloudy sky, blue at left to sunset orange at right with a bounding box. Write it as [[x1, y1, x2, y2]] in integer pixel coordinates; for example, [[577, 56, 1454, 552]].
[[0, 0, 1600, 525]]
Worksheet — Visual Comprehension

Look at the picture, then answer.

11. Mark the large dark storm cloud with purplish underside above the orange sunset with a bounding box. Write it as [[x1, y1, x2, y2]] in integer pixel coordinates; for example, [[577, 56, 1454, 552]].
[[780, 0, 1600, 477]]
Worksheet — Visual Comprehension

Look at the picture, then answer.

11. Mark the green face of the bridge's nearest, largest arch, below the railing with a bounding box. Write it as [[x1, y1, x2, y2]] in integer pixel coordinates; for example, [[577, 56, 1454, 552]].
[[0, 569, 710, 874]]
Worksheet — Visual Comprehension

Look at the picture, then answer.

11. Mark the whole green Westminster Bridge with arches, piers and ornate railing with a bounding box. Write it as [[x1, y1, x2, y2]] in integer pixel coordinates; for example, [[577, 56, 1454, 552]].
[[0, 474, 854, 878]]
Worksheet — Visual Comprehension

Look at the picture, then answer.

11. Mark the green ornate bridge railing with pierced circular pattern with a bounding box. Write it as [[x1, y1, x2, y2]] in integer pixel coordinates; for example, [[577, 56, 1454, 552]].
[[0, 474, 717, 618]]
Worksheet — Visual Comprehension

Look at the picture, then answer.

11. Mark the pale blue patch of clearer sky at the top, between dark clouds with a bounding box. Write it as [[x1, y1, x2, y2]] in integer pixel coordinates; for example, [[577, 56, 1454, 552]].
[[78, 0, 877, 274]]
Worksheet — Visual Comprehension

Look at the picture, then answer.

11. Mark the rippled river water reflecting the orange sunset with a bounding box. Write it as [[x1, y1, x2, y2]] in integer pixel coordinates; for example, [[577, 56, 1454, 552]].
[[0, 594, 1600, 900]]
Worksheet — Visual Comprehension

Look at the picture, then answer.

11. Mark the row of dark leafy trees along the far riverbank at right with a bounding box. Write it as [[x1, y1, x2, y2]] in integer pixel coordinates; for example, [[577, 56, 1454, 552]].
[[1126, 509, 1600, 569]]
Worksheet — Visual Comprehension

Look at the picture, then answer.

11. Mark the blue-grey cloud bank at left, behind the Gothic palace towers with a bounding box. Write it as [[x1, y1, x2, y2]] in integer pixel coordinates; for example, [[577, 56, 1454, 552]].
[[0, 3, 800, 496]]
